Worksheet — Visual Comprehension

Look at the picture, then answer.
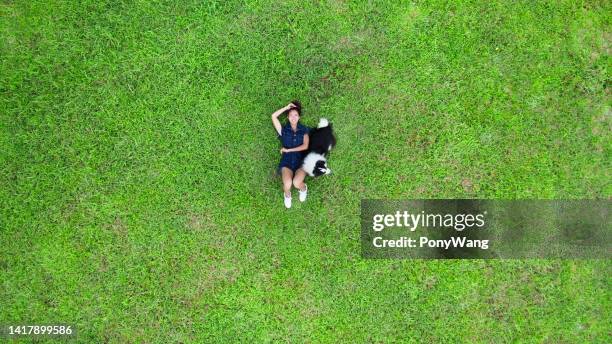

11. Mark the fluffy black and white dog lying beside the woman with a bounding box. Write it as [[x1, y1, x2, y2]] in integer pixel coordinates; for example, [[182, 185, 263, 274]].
[[302, 118, 336, 177]]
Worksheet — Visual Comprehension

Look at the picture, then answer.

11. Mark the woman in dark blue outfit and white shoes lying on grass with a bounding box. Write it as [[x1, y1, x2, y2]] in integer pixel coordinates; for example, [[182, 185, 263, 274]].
[[272, 100, 310, 208]]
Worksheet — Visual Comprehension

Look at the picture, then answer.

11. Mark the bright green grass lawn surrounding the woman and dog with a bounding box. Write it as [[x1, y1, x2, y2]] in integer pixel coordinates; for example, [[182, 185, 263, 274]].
[[0, 0, 612, 343]]
